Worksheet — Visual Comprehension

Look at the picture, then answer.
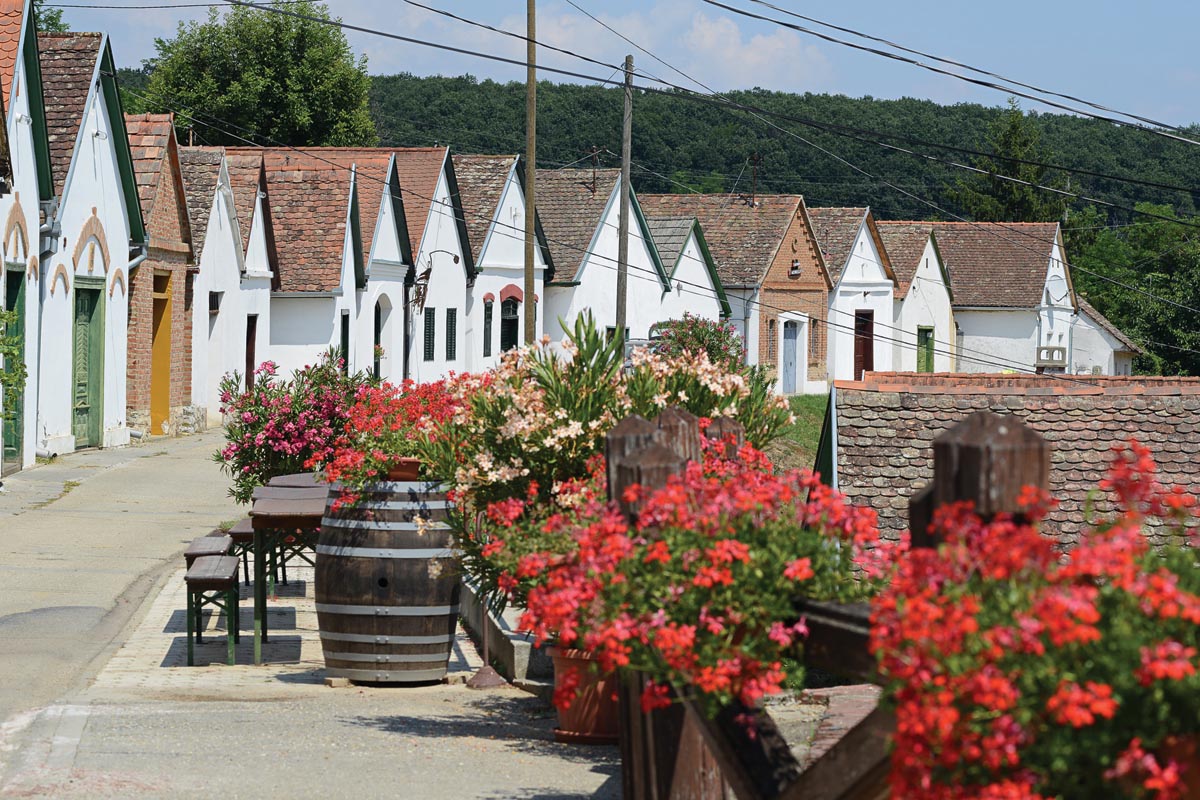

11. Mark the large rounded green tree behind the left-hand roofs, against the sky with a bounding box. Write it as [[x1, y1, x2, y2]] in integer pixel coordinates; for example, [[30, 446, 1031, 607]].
[[144, 0, 378, 146]]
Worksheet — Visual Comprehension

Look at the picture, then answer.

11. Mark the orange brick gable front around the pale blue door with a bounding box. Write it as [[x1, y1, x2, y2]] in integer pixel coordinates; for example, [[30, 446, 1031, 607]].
[[758, 206, 829, 380]]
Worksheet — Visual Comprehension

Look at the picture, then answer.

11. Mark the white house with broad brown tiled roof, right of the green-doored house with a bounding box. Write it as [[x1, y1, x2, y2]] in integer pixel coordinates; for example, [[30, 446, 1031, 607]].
[[934, 222, 1076, 372]]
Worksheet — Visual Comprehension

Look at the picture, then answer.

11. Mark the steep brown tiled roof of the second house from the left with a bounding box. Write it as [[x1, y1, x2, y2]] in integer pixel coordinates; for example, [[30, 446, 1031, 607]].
[[37, 32, 103, 196]]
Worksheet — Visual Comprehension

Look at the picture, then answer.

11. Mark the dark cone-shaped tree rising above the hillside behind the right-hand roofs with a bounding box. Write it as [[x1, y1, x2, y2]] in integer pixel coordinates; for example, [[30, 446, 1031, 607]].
[[953, 97, 1067, 222]]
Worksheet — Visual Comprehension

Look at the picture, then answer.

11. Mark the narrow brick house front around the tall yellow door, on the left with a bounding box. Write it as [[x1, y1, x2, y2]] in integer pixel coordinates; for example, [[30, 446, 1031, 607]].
[[126, 146, 192, 433]]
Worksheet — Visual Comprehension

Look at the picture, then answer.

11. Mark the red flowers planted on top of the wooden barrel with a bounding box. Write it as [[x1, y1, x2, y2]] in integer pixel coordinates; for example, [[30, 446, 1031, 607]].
[[305, 377, 458, 504]]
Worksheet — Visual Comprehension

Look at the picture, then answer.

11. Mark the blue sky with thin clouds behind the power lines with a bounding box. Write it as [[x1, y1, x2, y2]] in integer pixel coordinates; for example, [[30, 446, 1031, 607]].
[[65, 0, 1200, 125]]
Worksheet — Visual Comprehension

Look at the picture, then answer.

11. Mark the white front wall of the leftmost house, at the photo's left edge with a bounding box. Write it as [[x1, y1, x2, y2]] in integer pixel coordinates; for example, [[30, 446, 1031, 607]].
[[0, 38, 42, 467]]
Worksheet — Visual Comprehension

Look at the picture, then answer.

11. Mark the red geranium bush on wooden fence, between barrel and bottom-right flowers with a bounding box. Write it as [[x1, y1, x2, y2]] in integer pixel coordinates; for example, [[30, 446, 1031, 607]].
[[510, 446, 878, 714]]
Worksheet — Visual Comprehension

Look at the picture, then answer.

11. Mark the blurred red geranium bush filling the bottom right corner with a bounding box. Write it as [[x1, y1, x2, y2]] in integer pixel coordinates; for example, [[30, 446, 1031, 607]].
[[871, 443, 1200, 799]]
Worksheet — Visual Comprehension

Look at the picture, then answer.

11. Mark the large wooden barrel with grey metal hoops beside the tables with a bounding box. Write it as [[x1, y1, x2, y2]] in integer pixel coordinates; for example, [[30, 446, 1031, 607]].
[[314, 482, 460, 682]]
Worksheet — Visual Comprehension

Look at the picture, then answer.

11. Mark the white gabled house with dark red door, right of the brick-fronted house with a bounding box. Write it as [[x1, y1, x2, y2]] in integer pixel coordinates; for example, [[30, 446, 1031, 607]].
[[809, 207, 896, 380]]
